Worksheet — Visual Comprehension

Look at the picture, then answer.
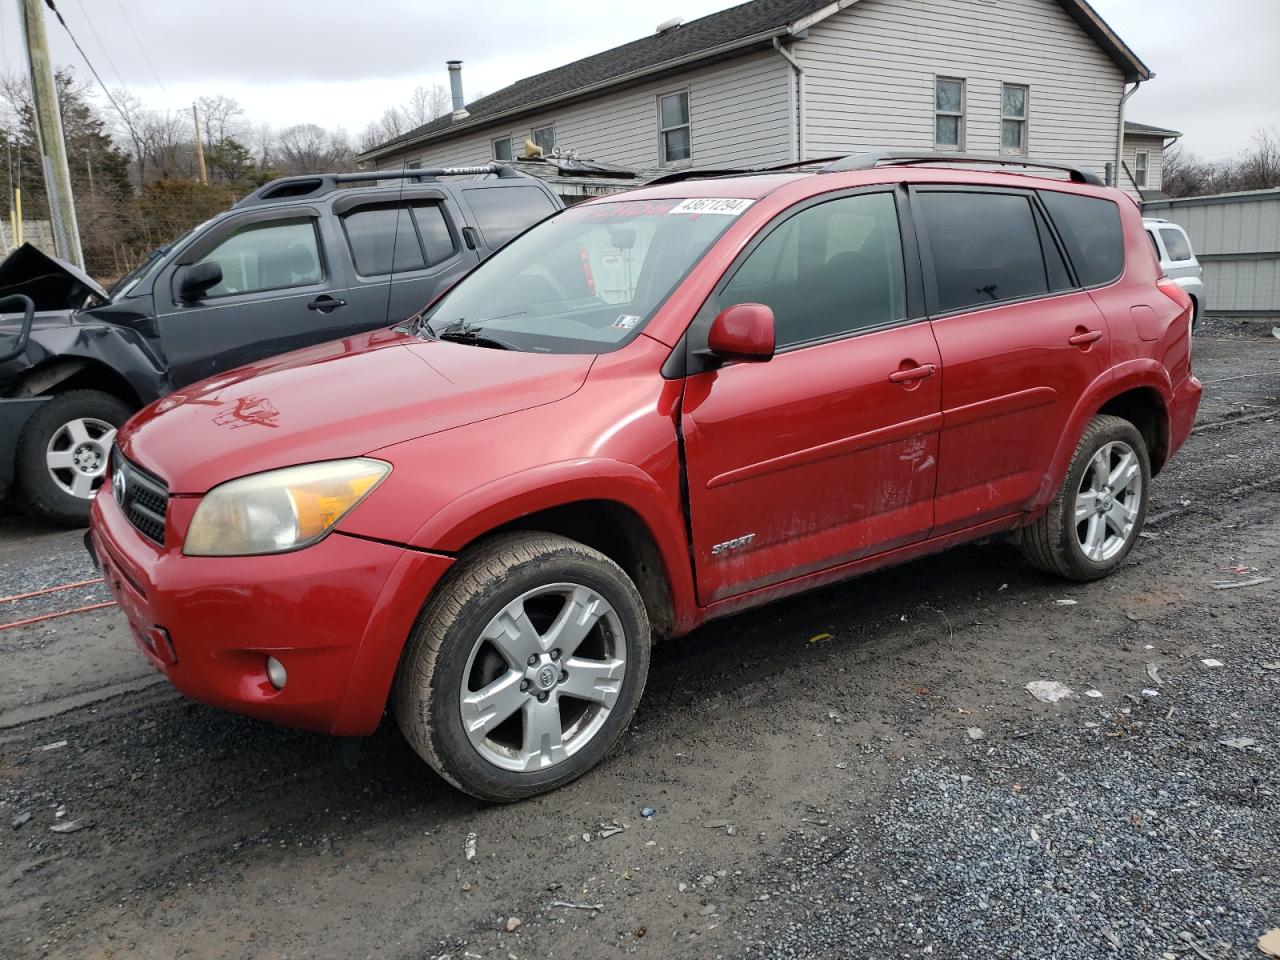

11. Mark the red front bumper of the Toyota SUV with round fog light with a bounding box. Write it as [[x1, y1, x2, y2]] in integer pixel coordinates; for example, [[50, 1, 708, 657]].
[[86, 485, 453, 736]]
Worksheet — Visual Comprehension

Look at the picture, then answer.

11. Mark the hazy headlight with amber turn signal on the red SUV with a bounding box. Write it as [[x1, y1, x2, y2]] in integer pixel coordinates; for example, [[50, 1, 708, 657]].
[[182, 457, 392, 557]]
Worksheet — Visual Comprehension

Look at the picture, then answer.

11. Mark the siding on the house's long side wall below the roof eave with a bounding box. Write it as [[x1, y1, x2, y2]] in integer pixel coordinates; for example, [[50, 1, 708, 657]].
[[378, 52, 795, 168]]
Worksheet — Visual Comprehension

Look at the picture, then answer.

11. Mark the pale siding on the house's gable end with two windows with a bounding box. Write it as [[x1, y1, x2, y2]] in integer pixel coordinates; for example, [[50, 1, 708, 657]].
[[795, 0, 1124, 175]]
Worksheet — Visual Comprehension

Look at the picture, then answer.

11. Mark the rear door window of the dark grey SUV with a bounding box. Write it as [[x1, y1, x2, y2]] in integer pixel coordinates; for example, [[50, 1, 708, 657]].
[[342, 204, 453, 276]]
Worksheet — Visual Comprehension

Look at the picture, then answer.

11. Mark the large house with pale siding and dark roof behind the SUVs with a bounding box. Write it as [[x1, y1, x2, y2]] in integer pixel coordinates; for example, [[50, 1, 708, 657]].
[[361, 0, 1152, 193]]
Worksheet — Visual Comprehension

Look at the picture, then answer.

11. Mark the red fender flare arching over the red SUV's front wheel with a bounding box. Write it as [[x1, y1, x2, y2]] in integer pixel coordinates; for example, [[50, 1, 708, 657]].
[[410, 458, 699, 632]]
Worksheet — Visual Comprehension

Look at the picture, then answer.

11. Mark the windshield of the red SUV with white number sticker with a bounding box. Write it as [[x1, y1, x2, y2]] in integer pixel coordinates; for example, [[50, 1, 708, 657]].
[[422, 200, 751, 353]]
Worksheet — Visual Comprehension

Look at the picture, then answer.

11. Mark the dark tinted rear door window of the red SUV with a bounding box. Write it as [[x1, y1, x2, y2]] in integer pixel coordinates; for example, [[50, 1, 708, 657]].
[[919, 191, 1048, 312]]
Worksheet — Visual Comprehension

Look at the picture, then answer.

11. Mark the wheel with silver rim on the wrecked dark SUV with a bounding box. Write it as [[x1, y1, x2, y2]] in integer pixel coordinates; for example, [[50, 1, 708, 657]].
[[14, 390, 133, 526]]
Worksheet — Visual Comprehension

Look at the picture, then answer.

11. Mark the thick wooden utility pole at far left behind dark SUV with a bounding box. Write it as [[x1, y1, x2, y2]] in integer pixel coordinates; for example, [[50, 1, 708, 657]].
[[18, 0, 84, 270]]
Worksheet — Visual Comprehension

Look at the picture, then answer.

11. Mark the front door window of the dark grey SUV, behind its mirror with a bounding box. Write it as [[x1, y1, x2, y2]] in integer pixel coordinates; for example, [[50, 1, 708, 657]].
[[200, 218, 324, 298]]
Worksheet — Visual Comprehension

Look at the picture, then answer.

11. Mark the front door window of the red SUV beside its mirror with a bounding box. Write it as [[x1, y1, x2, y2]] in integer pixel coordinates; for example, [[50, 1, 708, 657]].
[[719, 193, 906, 348]]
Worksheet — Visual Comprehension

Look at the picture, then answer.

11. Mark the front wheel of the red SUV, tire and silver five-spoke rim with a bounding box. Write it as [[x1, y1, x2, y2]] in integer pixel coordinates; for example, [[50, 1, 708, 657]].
[[393, 534, 650, 803]]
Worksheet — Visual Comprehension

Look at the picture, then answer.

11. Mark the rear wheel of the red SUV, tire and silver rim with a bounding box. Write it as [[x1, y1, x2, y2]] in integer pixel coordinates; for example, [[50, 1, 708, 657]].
[[1021, 415, 1151, 581]]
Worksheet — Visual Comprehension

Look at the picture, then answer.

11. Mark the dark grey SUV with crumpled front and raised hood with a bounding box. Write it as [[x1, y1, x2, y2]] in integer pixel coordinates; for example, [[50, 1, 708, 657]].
[[0, 164, 563, 524]]
